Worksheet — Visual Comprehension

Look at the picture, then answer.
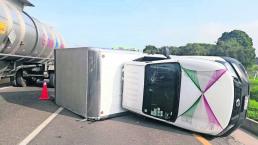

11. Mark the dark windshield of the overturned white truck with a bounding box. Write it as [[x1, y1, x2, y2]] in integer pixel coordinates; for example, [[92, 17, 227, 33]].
[[142, 63, 181, 121]]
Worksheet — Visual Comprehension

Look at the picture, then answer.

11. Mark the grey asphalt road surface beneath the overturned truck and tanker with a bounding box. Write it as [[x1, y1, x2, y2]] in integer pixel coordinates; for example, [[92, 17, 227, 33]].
[[0, 87, 258, 145]]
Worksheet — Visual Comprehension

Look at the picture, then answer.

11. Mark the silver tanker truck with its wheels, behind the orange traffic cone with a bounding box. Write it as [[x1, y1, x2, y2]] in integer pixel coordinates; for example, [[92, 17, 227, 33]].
[[0, 0, 64, 87]]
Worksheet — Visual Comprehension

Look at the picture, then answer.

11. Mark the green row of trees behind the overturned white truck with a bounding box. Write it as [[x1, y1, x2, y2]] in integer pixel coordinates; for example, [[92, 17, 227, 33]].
[[143, 30, 256, 67]]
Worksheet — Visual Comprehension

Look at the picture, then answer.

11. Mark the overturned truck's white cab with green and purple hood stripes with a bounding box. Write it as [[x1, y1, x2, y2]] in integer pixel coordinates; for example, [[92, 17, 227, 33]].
[[122, 56, 249, 136]]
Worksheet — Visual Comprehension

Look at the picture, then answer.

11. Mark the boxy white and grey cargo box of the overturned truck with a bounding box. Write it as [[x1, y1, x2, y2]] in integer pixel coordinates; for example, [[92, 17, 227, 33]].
[[55, 48, 143, 120]]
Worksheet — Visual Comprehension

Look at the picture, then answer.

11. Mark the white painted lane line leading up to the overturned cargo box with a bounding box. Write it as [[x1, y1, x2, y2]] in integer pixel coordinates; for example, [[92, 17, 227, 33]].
[[18, 107, 64, 145]]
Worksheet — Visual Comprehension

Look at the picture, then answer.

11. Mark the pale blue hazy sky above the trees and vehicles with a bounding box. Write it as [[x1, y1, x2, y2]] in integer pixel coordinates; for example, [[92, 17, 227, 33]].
[[25, 0, 258, 54]]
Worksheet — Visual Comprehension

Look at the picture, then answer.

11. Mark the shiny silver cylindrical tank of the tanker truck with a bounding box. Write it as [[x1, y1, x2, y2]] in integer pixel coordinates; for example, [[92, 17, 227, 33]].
[[0, 0, 64, 62]]
